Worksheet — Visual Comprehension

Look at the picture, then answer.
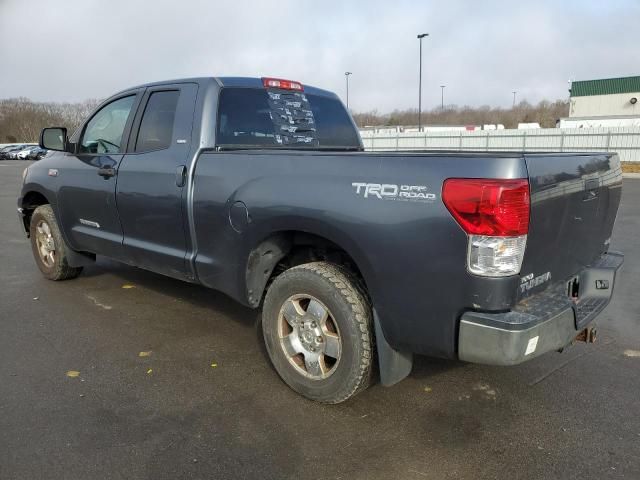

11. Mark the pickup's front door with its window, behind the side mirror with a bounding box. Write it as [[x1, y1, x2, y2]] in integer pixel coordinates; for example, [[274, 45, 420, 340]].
[[55, 92, 141, 259]]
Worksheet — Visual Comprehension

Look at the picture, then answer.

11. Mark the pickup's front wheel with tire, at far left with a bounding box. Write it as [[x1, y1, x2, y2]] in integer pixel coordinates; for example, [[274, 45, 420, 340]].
[[29, 205, 82, 280]]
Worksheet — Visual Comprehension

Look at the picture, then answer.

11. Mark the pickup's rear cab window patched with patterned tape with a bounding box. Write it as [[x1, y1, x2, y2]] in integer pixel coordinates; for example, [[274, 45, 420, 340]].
[[217, 88, 360, 149]]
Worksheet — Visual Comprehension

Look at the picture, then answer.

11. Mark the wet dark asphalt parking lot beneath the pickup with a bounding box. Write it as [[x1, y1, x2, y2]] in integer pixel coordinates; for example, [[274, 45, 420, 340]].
[[0, 161, 640, 480]]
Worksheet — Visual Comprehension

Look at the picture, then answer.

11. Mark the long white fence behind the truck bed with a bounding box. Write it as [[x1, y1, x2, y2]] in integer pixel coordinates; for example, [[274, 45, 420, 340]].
[[360, 127, 640, 162]]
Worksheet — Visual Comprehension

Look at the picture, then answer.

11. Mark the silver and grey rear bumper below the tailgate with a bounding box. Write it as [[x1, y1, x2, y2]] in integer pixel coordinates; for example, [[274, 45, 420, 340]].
[[458, 252, 624, 365]]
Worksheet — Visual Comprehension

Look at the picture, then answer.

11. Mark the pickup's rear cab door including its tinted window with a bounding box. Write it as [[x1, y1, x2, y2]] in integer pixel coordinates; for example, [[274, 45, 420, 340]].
[[116, 83, 198, 278]]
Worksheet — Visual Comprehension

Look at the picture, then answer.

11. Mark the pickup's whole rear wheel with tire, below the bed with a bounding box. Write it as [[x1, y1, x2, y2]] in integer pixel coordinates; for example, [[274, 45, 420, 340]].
[[262, 262, 373, 403]]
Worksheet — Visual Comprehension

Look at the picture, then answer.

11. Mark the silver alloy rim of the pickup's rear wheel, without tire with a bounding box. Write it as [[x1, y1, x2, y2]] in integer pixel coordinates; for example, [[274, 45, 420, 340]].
[[278, 294, 342, 380]]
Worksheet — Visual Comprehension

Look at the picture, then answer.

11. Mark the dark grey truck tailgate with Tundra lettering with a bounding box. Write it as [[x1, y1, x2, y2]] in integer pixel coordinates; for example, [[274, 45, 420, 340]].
[[519, 153, 622, 297]]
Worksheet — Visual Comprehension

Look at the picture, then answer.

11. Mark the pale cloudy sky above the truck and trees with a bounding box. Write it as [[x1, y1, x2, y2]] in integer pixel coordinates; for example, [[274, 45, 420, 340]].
[[0, 0, 640, 113]]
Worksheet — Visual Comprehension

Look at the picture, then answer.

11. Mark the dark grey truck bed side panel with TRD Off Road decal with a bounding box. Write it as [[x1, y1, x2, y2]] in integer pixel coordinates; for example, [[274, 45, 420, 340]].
[[193, 151, 527, 357]]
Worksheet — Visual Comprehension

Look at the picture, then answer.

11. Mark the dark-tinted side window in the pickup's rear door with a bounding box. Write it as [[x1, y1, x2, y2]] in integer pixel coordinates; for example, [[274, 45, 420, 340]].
[[135, 90, 180, 152]]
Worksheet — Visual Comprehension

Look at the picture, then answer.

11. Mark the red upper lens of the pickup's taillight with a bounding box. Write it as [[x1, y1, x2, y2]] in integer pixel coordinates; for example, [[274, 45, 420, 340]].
[[442, 178, 530, 237]]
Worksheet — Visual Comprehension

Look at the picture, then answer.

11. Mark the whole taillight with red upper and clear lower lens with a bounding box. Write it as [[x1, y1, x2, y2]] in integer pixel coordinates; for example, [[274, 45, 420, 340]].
[[442, 178, 531, 277]]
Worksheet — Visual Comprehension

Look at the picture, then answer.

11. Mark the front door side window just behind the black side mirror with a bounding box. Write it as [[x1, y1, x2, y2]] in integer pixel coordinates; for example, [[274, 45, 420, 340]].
[[80, 95, 136, 154]]
